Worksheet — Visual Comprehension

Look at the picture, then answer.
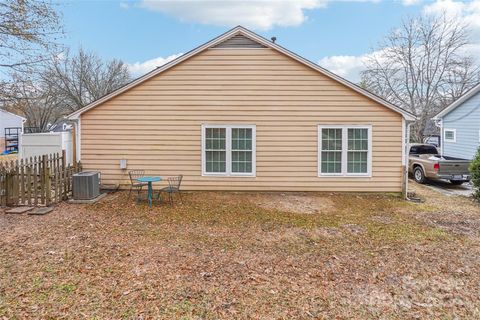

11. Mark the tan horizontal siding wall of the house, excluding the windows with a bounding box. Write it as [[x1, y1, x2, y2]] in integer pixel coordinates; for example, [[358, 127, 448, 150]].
[[81, 49, 402, 192]]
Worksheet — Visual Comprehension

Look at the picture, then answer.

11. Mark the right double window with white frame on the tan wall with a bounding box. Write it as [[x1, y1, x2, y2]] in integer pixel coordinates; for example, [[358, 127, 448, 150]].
[[318, 125, 372, 176]]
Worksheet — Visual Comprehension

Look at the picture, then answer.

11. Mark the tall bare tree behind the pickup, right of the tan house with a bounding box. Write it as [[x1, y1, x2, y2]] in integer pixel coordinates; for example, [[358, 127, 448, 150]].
[[362, 15, 479, 141]]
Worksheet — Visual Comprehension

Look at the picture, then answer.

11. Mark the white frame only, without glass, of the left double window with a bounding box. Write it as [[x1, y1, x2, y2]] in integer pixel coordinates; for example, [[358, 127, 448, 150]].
[[201, 124, 257, 177]]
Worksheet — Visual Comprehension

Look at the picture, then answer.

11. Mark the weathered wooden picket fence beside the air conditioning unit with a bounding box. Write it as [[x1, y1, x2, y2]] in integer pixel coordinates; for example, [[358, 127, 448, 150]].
[[0, 150, 81, 206]]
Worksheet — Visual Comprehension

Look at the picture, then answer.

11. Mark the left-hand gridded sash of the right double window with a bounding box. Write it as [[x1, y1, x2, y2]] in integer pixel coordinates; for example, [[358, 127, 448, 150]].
[[320, 128, 342, 173]]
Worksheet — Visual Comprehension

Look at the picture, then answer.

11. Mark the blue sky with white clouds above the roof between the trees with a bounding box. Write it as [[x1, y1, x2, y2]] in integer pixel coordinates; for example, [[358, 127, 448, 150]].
[[59, 0, 480, 82]]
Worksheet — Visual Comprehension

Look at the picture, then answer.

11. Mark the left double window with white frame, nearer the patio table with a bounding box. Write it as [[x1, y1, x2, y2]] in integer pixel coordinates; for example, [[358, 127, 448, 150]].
[[202, 125, 255, 176]]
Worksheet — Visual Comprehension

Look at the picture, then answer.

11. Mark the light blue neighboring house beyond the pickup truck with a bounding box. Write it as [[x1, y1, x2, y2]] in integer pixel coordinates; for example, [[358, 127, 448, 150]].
[[434, 84, 480, 159]]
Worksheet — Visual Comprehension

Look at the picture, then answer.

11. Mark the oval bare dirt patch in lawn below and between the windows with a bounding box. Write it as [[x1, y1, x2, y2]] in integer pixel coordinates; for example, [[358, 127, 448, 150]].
[[252, 193, 335, 214]]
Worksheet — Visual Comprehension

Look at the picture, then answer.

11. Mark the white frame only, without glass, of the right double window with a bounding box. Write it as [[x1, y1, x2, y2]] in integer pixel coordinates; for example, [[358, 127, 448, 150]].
[[317, 124, 373, 178]]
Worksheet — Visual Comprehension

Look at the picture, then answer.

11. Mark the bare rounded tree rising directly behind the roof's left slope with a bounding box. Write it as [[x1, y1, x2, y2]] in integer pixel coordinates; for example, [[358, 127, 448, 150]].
[[42, 49, 130, 113]]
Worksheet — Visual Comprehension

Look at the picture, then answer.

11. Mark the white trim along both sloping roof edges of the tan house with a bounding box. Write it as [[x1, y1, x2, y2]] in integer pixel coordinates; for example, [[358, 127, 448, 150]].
[[67, 26, 416, 121]]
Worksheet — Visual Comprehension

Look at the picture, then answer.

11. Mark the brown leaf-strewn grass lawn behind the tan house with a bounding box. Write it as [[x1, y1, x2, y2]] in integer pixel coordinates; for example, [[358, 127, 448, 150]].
[[0, 186, 480, 319]]
